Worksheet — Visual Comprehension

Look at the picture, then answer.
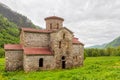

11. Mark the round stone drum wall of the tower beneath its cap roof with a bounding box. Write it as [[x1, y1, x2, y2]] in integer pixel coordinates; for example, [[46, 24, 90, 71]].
[[46, 19, 63, 30]]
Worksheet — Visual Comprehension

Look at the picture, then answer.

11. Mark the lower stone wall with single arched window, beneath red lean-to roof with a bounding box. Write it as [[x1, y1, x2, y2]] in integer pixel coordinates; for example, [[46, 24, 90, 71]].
[[23, 55, 55, 72]]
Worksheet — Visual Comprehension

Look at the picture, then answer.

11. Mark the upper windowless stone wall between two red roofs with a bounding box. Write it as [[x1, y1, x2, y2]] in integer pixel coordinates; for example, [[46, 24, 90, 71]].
[[24, 32, 50, 47]]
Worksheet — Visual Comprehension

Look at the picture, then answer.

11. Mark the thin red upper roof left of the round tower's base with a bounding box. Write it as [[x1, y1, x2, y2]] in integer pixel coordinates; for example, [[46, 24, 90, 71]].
[[21, 28, 52, 33]]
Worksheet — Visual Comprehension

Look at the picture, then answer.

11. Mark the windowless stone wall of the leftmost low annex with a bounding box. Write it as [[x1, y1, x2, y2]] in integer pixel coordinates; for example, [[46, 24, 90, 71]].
[[5, 50, 23, 71]]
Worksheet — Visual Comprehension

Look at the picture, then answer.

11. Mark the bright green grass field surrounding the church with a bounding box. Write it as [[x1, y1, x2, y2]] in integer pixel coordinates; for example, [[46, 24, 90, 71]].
[[0, 57, 120, 80]]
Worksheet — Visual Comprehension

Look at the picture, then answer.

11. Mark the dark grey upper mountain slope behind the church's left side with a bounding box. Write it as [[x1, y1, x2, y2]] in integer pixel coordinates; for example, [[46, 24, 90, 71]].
[[0, 3, 38, 28]]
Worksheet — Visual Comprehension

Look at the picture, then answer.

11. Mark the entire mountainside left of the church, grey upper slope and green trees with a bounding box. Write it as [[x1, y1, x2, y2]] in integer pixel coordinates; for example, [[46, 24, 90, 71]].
[[0, 3, 40, 57]]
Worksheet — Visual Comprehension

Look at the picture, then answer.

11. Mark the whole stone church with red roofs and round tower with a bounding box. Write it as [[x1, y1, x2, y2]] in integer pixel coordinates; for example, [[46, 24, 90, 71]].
[[4, 16, 84, 71]]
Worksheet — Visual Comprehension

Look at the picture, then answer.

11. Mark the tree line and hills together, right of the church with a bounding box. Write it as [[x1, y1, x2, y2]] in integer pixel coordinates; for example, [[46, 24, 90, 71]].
[[85, 36, 120, 57]]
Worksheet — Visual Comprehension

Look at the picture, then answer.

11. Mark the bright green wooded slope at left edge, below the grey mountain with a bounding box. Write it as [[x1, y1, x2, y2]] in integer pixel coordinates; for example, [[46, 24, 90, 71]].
[[0, 15, 19, 57]]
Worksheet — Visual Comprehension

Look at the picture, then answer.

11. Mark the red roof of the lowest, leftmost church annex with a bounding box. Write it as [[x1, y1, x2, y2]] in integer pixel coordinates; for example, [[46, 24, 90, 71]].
[[4, 44, 23, 50]]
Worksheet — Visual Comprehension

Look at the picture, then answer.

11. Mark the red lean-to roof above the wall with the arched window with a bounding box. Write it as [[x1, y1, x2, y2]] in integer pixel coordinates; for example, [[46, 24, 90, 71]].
[[24, 48, 52, 55]]
